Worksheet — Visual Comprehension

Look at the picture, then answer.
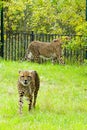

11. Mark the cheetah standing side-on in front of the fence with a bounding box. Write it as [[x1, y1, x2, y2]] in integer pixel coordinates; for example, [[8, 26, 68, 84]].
[[25, 38, 64, 64]]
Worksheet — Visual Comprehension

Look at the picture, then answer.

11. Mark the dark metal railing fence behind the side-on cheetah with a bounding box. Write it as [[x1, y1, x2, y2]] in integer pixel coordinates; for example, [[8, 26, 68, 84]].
[[3, 32, 87, 62]]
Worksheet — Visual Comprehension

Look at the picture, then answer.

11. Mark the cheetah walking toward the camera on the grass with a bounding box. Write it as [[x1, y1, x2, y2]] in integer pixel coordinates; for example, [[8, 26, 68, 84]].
[[18, 71, 40, 114]]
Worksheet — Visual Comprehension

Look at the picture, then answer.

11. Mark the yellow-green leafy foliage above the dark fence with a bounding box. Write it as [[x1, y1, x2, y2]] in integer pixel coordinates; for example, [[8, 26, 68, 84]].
[[2, 0, 87, 35]]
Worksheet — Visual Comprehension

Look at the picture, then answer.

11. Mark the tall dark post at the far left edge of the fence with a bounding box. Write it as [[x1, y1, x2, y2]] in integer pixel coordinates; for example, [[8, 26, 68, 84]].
[[0, 0, 4, 57]]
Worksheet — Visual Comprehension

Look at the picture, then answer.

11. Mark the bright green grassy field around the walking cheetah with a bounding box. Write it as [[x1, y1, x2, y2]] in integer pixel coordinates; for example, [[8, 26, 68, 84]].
[[0, 60, 87, 130]]
